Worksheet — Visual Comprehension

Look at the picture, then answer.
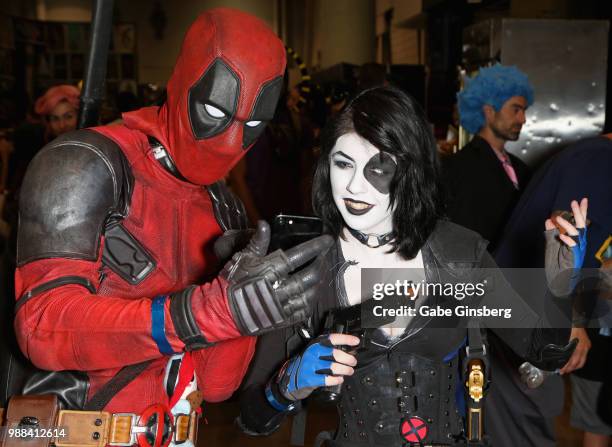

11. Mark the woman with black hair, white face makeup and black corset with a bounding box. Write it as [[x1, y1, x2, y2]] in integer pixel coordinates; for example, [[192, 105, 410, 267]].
[[238, 87, 587, 446]]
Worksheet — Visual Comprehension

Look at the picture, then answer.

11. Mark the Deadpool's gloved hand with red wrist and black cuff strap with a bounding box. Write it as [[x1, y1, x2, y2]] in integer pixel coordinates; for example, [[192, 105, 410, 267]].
[[167, 221, 333, 352]]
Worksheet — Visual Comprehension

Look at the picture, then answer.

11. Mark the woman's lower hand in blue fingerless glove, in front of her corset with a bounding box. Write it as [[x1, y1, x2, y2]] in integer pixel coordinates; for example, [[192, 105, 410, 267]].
[[267, 334, 359, 401]]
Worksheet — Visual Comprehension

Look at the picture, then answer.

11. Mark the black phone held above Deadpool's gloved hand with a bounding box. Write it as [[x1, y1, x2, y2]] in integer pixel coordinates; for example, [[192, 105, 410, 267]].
[[270, 214, 323, 251]]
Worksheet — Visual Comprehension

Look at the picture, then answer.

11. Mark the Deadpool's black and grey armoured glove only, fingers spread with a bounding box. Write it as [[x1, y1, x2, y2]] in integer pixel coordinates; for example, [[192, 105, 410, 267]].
[[220, 221, 333, 335]]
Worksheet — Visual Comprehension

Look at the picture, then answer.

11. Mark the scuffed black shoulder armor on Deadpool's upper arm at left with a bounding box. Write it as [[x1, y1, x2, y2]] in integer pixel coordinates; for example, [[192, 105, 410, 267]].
[[17, 130, 134, 265]]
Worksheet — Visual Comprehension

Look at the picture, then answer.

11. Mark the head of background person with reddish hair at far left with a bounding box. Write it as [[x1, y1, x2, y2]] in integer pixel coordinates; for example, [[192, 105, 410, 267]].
[[34, 85, 81, 141]]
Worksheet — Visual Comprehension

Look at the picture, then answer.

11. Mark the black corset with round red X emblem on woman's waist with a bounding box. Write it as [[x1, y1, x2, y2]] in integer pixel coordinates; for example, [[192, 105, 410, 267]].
[[333, 352, 464, 446]]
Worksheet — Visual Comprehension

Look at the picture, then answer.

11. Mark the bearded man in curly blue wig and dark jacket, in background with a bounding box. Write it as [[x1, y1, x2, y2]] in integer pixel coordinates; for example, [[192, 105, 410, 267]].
[[443, 64, 533, 252]]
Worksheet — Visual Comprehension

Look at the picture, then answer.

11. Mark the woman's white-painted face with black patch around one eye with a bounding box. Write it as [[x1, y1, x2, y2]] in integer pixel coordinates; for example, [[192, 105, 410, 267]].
[[330, 132, 397, 236]]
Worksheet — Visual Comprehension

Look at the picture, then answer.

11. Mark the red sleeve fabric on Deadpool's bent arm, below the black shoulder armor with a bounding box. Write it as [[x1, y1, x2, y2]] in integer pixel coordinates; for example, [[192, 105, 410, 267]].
[[15, 254, 240, 371]]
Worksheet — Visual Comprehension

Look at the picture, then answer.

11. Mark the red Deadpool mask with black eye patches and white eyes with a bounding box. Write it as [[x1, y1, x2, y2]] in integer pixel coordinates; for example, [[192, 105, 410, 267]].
[[163, 8, 285, 185]]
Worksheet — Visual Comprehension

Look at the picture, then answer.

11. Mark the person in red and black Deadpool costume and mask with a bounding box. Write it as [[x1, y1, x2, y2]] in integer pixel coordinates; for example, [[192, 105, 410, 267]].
[[15, 9, 328, 413]]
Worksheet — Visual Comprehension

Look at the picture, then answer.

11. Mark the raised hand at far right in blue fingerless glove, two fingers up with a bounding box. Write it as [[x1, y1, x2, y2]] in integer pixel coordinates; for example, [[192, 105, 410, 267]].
[[544, 198, 588, 296]]
